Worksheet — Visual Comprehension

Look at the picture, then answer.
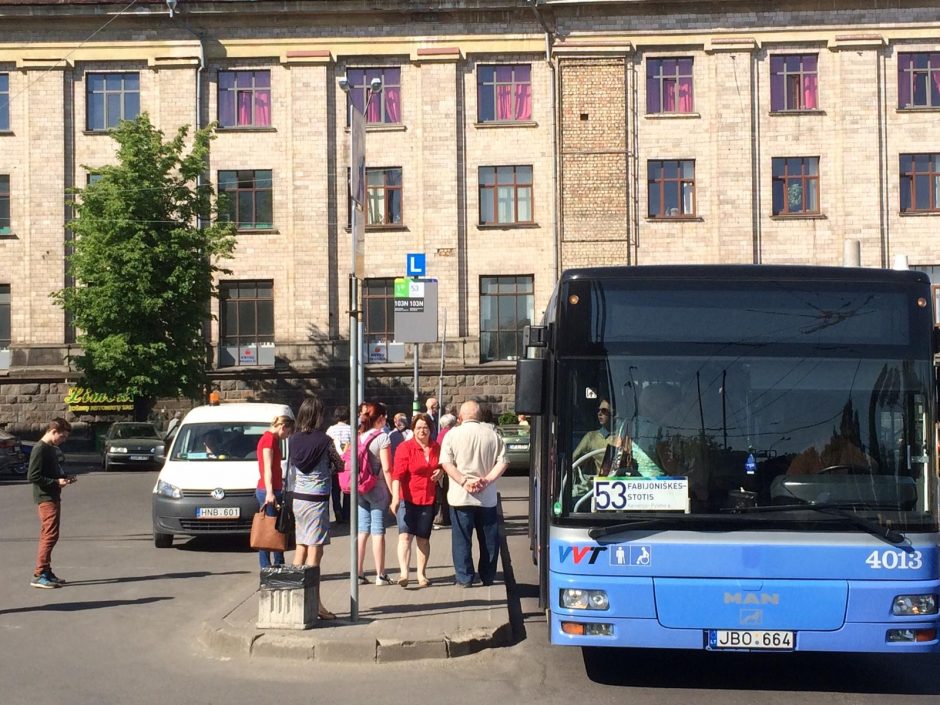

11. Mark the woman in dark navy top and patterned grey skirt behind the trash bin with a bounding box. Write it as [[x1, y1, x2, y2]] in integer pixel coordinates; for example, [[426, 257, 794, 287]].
[[288, 397, 342, 619]]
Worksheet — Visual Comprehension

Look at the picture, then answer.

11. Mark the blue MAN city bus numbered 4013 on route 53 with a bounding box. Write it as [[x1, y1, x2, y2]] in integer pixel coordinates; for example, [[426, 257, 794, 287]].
[[516, 265, 940, 653]]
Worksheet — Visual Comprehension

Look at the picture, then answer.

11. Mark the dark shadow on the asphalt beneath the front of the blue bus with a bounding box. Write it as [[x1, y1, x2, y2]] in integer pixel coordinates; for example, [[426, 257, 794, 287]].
[[582, 647, 940, 695]]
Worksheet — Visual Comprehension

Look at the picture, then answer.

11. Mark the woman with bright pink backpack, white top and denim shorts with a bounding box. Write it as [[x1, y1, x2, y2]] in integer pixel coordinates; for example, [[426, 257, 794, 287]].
[[357, 402, 392, 585]]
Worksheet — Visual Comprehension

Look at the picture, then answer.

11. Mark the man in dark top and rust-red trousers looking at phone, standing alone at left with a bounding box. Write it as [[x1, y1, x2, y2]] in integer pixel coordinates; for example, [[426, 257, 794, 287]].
[[27, 418, 76, 589]]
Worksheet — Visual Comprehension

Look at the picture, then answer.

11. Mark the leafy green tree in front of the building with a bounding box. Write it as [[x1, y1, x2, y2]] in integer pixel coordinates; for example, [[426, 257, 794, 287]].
[[53, 113, 235, 418]]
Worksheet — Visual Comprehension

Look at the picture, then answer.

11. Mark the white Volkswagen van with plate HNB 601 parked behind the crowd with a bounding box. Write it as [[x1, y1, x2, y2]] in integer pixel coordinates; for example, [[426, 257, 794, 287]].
[[153, 403, 294, 548]]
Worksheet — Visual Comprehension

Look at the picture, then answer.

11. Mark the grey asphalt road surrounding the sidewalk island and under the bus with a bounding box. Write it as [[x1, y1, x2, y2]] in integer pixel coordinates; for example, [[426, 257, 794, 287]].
[[0, 461, 940, 705]]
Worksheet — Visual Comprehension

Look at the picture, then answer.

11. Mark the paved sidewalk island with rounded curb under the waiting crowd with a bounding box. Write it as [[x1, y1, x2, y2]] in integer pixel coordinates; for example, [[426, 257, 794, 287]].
[[200, 500, 513, 663]]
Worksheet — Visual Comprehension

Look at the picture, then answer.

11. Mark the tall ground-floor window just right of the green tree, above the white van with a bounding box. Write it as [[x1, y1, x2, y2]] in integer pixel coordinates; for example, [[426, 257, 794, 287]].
[[219, 280, 274, 367]]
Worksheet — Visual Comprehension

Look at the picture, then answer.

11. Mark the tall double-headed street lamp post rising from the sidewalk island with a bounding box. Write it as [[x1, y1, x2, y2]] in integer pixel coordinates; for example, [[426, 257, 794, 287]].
[[339, 76, 382, 622]]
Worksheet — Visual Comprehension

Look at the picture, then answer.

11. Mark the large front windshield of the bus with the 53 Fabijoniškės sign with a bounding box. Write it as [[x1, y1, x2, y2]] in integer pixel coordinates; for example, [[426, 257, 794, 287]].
[[552, 281, 937, 531]]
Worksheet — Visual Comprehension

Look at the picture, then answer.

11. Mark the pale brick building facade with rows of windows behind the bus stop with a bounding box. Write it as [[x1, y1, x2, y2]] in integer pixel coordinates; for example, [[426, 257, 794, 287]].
[[0, 0, 940, 430]]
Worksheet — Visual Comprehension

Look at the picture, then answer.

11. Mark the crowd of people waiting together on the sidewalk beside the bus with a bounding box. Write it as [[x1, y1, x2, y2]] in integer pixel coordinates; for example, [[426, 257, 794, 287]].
[[257, 397, 507, 620]]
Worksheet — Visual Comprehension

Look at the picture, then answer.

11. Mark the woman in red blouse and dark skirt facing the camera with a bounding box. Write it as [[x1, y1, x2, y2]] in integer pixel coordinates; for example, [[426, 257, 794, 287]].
[[390, 414, 444, 587]]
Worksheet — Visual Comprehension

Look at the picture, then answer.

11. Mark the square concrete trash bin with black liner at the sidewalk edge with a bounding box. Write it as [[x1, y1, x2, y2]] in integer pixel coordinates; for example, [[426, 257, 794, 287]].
[[258, 565, 320, 629]]
